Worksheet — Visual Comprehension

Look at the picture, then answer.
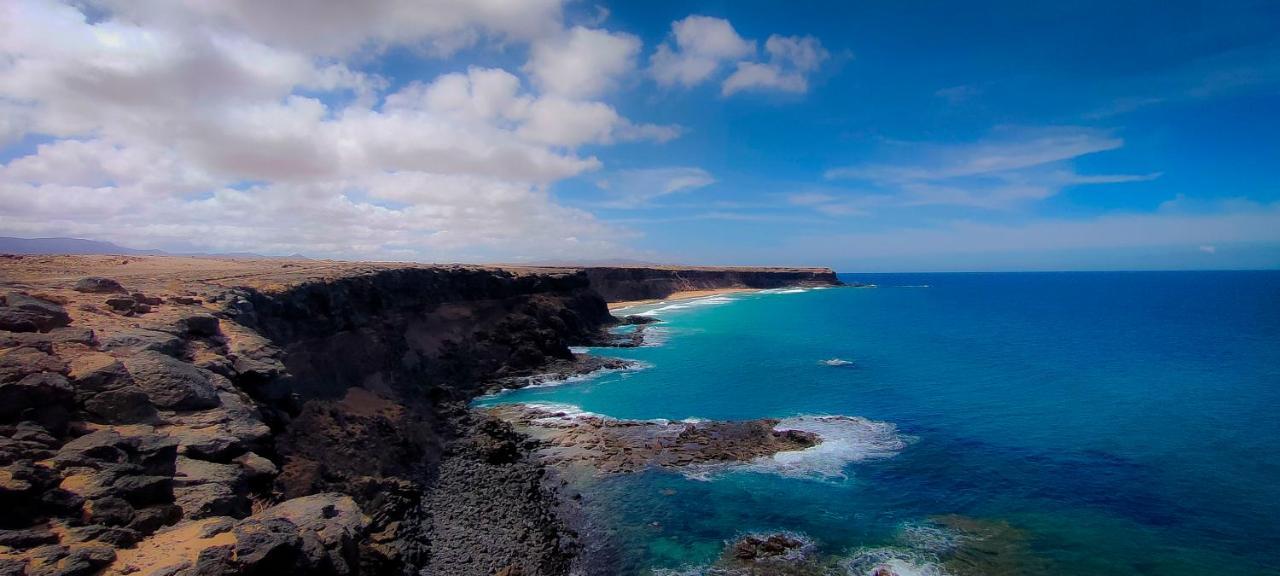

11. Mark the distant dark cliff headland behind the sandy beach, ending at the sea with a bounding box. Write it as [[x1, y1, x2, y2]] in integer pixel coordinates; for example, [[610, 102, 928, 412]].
[[584, 268, 841, 302]]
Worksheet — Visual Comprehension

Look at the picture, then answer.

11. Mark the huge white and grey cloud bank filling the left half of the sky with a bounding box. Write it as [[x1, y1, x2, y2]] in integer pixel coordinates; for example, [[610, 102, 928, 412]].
[[0, 0, 680, 260]]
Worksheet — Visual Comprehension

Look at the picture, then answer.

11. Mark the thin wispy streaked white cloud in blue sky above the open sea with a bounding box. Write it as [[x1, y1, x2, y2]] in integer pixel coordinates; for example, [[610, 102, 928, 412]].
[[826, 127, 1161, 210]]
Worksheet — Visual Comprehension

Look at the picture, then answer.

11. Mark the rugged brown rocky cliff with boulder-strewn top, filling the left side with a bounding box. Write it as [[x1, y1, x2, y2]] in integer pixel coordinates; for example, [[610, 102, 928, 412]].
[[0, 256, 835, 575]]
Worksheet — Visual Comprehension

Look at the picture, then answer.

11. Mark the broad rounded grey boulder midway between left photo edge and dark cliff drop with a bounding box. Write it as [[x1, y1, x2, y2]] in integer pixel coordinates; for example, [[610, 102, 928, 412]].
[[124, 351, 221, 410]]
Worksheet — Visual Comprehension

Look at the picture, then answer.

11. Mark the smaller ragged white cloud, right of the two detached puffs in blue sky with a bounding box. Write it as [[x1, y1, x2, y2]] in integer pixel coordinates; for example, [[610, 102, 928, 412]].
[[721, 35, 831, 96]]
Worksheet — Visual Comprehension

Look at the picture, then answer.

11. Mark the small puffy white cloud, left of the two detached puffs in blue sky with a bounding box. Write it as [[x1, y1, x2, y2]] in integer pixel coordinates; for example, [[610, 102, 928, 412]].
[[649, 15, 755, 87]]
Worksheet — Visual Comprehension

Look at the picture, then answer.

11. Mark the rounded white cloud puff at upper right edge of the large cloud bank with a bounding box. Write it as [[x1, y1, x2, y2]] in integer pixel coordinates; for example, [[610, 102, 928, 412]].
[[525, 26, 641, 97]]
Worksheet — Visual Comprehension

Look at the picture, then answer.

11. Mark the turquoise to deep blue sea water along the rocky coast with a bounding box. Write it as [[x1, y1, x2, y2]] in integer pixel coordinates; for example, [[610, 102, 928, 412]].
[[481, 273, 1280, 575]]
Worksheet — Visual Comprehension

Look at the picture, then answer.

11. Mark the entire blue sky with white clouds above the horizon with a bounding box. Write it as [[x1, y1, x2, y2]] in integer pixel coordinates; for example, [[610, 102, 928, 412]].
[[0, 0, 1280, 271]]
